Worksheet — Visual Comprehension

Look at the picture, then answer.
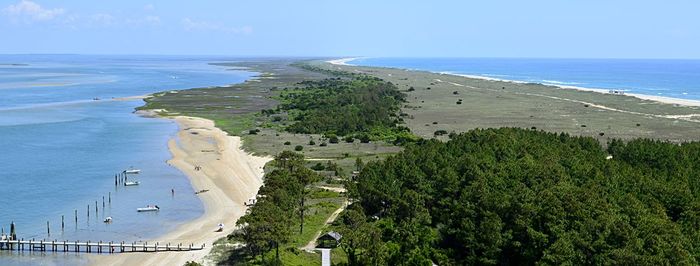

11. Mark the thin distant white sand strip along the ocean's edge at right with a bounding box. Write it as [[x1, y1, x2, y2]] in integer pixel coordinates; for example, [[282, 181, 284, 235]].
[[325, 57, 700, 107]]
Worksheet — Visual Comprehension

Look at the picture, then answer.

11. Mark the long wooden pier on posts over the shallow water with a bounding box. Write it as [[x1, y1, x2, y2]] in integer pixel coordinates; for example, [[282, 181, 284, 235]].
[[0, 240, 204, 253]]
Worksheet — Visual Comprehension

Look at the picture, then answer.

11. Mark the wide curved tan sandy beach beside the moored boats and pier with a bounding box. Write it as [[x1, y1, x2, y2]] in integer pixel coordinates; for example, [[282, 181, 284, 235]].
[[89, 117, 271, 265]]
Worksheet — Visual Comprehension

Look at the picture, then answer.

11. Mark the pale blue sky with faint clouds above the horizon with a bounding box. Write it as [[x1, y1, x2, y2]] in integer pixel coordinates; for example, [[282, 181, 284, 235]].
[[0, 0, 700, 59]]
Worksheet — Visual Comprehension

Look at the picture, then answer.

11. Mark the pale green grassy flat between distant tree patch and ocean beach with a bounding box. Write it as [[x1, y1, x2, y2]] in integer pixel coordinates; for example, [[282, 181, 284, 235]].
[[312, 61, 700, 143]]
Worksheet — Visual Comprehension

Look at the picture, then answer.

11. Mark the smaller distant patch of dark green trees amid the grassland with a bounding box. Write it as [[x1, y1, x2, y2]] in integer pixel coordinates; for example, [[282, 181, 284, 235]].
[[279, 76, 412, 141]]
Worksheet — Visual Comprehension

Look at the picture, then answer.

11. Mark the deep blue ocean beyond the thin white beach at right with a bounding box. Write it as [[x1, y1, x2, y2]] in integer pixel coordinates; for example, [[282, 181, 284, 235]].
[[349, 58, 700, 100]]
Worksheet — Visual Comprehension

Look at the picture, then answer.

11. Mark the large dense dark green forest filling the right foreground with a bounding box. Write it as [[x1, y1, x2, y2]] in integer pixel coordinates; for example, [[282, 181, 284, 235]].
[[336, 128, 700, 265]]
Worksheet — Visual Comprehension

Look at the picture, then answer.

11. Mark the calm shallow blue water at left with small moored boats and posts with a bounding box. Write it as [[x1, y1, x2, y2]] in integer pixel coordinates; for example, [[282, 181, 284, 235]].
[[0, 55, 254, 265]]
